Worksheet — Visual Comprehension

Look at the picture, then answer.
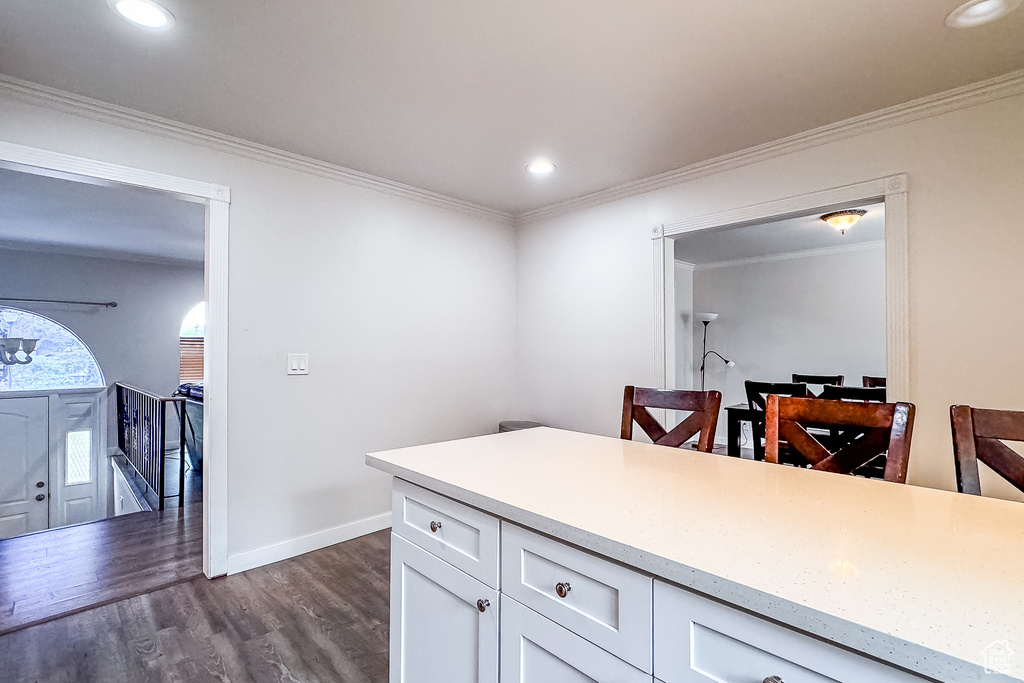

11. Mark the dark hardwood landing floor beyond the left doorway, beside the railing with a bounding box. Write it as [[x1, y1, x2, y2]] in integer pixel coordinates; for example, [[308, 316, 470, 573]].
[[0, 454, 203, 634]]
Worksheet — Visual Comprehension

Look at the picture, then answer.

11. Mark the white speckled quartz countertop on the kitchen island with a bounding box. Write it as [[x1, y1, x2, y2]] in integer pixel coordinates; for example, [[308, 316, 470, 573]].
[[367, 428, 1024, 683]]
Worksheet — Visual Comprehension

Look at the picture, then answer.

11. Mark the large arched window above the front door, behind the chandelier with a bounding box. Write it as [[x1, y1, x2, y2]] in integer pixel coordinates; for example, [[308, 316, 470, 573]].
[[0, 306, 106, 392]]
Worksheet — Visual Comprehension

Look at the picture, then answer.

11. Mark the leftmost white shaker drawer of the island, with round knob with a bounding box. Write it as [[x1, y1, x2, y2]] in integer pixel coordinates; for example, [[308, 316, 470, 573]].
[[391, 478, 498, 588]]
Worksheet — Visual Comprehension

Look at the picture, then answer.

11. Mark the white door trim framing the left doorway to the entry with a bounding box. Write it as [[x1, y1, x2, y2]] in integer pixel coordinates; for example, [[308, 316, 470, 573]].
[[0, 140, 230, 579]]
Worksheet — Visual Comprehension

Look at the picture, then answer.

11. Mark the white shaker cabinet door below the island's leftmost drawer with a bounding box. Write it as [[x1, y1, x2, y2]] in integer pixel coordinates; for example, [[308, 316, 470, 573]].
[[390, 533, 498, 683]]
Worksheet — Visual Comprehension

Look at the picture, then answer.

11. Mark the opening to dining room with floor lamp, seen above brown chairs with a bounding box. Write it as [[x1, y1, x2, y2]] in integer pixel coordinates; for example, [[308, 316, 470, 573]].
[[670, 202, 886, 457]]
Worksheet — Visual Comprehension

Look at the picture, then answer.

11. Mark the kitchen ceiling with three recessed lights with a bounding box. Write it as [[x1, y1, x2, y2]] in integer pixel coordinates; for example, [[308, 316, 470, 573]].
[[0, 0, 1024, 214]]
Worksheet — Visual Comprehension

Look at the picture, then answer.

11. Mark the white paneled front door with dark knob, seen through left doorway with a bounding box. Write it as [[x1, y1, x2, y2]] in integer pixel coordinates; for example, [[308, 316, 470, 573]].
[[0, 396, 49, 539]]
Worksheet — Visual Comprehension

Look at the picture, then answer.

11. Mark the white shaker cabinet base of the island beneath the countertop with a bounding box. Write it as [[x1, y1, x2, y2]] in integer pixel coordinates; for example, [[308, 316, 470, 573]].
[[390, 479, 923, 683]]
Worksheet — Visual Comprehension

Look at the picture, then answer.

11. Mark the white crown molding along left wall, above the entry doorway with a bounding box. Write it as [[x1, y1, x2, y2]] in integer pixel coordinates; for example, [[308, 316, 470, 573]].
[[0, 74, 513, 223]]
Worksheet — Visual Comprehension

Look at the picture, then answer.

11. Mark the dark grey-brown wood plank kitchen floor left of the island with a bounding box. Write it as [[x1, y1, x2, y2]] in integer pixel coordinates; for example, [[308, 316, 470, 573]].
[[0, 530, 391, 683]]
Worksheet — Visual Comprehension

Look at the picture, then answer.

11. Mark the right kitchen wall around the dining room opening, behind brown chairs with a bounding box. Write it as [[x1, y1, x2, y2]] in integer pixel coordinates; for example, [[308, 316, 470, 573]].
[[517, 90, 1024, 499]]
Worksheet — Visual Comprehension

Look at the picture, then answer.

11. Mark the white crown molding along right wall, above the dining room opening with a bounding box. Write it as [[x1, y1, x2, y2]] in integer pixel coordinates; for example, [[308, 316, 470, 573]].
[[516, 70, 1024, 224]]
